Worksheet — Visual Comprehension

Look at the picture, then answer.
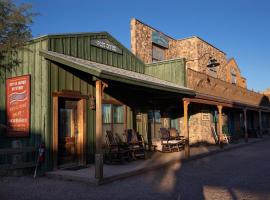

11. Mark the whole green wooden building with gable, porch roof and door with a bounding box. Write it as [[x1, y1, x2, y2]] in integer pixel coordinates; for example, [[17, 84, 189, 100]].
[[0, 32, 194, 171]]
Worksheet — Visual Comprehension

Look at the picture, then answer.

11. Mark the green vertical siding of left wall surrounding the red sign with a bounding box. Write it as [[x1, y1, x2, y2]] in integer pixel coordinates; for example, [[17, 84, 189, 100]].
[[0, 39, 49, 152]]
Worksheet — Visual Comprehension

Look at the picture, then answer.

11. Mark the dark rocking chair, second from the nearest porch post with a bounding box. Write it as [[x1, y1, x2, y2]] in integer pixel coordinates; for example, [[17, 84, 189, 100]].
[[124, 129, 145, 159]]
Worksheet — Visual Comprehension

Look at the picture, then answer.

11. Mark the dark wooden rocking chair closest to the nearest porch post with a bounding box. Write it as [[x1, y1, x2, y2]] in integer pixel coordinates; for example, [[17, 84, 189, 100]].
[[105, 130, 131, 163]]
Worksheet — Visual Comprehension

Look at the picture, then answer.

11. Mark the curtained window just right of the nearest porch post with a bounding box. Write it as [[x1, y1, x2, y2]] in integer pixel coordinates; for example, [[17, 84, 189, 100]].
[[102, 104, 124, 124]]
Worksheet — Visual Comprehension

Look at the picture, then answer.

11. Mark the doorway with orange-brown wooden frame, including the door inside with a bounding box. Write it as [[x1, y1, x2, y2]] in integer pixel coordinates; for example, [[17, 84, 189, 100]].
[[53, 93, 86, 168]]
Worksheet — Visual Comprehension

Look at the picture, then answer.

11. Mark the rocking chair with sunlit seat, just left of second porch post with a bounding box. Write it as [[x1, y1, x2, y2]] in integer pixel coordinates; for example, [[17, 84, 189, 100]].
[[160, 128, 185, 152]]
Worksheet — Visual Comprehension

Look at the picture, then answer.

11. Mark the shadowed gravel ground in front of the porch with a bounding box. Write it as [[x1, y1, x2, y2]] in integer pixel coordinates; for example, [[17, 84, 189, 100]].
[[0, 140, 270, 200]]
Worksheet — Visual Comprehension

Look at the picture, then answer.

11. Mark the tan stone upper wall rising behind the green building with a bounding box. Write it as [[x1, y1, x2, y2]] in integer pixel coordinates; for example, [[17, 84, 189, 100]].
[[131, 19, 246, 88]]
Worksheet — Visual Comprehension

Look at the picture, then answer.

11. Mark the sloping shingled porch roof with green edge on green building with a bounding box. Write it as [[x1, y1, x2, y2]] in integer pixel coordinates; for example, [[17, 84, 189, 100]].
[[40, 50, 195, 95]]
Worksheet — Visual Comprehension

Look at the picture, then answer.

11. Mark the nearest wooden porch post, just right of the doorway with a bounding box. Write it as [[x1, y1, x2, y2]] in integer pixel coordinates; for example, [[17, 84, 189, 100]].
[[95, 80, 103, 181]]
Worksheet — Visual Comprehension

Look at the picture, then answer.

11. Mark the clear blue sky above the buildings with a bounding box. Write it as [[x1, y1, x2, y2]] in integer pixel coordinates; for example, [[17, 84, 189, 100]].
[[15, 0, 270, 91]]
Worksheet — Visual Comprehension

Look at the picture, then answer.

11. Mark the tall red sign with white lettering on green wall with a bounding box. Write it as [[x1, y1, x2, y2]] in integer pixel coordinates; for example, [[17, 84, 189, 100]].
[[6, 75, 30, 137]]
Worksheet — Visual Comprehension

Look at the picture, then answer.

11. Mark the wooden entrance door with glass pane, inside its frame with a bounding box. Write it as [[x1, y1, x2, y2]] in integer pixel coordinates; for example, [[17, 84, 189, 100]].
[[58, 98, 79, 165]]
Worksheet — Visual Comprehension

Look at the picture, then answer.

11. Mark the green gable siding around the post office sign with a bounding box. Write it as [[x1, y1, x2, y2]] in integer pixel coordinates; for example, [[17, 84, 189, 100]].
[[49, 33, 145, 73]]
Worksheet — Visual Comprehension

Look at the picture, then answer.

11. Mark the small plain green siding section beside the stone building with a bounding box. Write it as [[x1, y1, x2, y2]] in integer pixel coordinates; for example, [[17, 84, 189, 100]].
[[145, 59, 186, 86]]
